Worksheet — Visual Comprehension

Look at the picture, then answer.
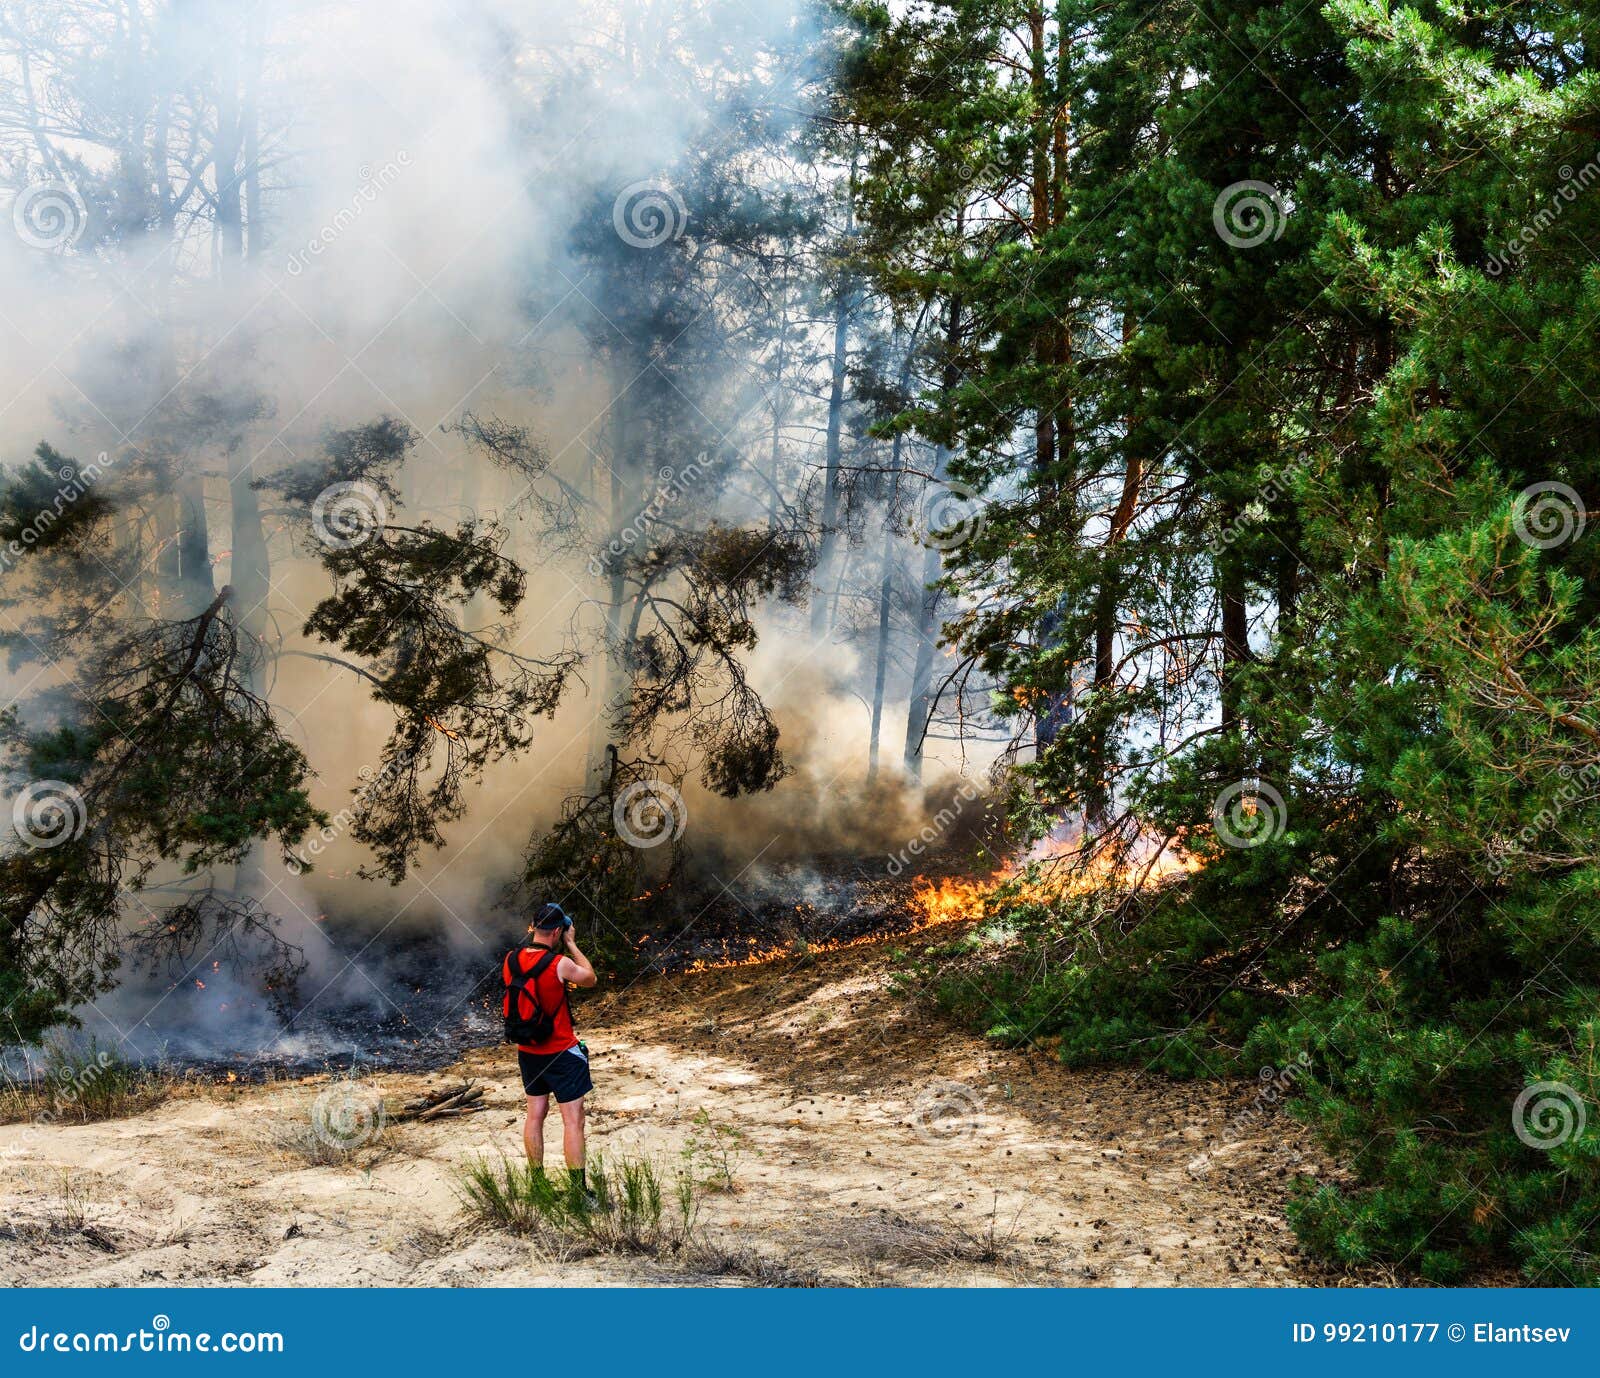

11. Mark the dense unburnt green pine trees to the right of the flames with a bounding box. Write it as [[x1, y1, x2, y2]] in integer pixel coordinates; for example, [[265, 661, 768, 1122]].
[[867, 0, 1600, 1285]]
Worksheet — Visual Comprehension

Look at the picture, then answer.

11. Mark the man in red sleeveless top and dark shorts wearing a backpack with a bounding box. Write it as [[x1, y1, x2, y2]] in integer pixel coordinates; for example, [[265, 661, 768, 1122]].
[[506, 904, 598, 1192]]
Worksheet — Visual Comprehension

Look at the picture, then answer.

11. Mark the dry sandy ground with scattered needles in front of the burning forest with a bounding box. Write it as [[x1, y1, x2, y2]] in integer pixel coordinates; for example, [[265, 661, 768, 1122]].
[[0, 939, 1382, 1287]]
